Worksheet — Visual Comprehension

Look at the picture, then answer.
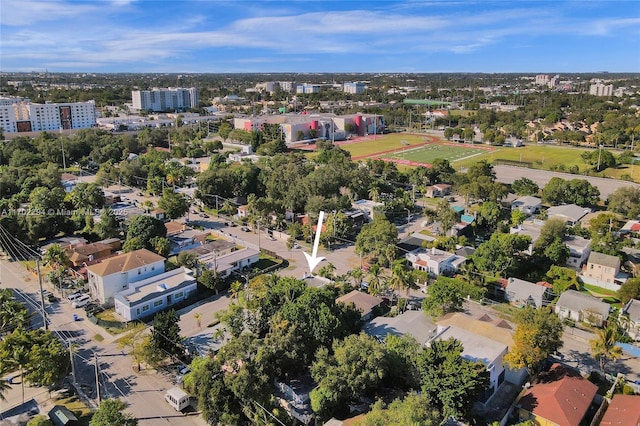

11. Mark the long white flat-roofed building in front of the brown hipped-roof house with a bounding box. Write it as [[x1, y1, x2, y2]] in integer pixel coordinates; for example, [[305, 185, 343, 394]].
[[114, 267, 197, 321]]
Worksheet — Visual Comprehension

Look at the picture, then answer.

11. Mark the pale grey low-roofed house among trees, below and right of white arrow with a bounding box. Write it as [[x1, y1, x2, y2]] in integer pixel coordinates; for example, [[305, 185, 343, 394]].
[[364, 310, 436, 346]]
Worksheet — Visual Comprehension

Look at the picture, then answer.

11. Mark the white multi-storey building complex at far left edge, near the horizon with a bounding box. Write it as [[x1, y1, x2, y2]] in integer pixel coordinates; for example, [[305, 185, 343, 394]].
[[0, 98, 96, 133]]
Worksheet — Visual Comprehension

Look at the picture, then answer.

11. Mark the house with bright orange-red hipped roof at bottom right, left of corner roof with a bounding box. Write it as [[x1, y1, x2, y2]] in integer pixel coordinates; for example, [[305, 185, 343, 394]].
[[516, 364, 598, 426]]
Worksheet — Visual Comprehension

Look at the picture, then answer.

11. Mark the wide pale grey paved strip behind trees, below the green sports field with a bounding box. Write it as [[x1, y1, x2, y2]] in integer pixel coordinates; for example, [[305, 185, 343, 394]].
[[493, 165, 640, 200]]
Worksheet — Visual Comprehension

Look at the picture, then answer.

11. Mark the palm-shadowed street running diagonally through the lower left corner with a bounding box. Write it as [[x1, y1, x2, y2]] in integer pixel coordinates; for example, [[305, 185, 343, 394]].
[[0, 260, 206, 425]]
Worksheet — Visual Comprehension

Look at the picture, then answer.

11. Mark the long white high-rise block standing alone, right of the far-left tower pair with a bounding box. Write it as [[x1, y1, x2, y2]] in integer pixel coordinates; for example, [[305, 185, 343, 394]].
[[131, 87, 198, 112]]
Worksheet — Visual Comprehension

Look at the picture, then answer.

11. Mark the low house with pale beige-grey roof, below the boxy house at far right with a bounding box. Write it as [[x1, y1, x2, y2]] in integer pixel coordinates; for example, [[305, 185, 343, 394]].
[[555, 290, 611, 327]]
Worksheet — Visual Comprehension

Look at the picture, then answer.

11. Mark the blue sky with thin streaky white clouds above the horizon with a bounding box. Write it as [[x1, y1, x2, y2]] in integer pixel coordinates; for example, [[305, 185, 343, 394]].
[[0, 0, 640, 73]]
